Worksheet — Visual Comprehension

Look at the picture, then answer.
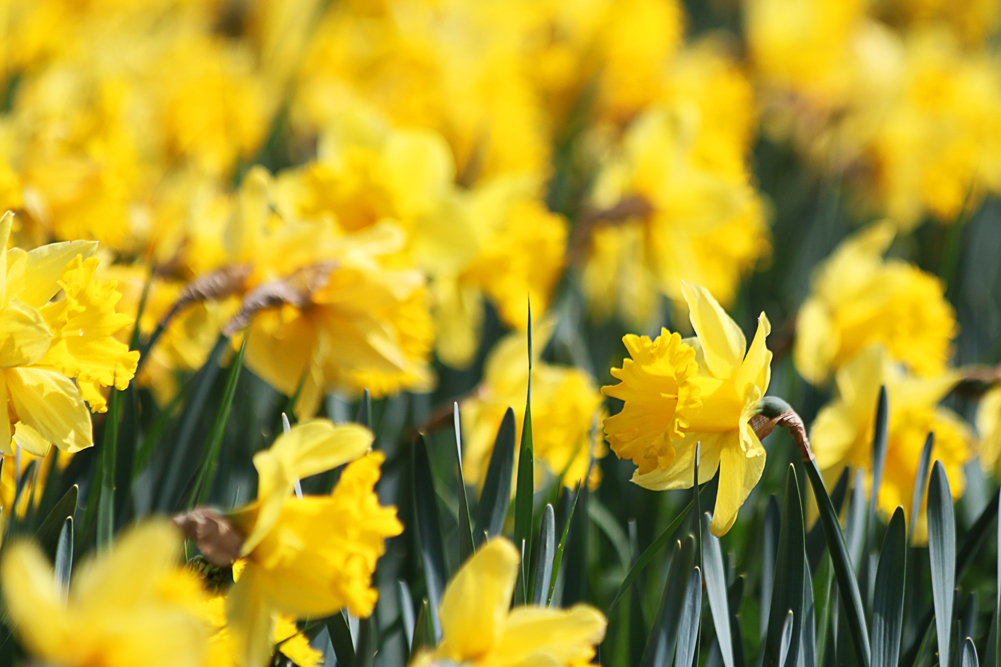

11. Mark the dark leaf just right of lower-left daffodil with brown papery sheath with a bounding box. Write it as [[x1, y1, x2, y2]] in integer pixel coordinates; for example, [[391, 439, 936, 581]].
[[411, 434, 448, 643]]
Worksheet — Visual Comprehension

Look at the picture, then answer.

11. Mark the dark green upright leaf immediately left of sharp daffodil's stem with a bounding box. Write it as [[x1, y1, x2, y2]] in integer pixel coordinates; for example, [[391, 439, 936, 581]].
[[765, 464, 806, 665]]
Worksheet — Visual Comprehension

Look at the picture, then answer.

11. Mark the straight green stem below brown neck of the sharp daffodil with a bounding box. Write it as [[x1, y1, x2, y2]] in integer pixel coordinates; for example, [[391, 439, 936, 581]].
[[804, 460, 872, 667]]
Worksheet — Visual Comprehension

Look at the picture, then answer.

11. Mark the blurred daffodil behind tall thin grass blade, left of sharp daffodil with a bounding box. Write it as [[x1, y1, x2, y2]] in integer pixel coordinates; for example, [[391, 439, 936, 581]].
[[460, 321, 607, 488]]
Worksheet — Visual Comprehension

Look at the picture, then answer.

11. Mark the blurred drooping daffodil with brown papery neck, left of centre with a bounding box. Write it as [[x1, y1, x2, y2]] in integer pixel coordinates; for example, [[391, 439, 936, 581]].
[[246, 223, 433, 416]]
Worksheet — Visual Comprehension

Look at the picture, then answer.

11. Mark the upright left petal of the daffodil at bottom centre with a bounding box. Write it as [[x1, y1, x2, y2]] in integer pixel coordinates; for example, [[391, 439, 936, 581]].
[[437, 538, 521, 662]]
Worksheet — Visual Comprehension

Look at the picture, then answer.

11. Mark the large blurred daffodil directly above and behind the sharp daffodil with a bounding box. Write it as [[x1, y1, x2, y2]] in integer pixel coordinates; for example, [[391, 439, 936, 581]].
[[583, 102, 769, 327]]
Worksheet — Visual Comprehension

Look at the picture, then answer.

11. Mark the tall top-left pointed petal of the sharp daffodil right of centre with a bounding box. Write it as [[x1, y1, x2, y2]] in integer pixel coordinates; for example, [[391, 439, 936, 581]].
[[682, 281, 747, 380]]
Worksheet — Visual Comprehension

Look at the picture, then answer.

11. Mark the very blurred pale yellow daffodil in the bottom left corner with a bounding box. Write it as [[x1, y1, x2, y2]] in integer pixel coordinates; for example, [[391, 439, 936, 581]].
[[0, 521, 209, 667]]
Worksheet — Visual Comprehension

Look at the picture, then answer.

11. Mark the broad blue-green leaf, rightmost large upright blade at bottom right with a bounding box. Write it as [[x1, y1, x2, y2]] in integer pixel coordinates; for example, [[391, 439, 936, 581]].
[[928, 461, 956, 664]]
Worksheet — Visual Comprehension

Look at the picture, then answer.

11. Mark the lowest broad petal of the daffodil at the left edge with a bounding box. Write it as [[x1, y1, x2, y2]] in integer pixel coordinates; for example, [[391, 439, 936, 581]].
[[4, 369, 94, 452]]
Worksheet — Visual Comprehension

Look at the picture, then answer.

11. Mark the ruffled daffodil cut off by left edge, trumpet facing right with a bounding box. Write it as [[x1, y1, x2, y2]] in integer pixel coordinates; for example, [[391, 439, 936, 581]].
[[0, 212, 139, 456]]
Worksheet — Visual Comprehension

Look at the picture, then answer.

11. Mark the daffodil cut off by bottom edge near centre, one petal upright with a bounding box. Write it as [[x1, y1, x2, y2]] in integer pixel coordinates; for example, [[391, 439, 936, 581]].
[[411, 538, 606, 667]]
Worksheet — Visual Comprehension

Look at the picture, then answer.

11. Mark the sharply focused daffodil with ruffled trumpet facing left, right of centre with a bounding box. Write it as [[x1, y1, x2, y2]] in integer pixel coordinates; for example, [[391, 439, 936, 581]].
[[602, 282, 772, 536]]
